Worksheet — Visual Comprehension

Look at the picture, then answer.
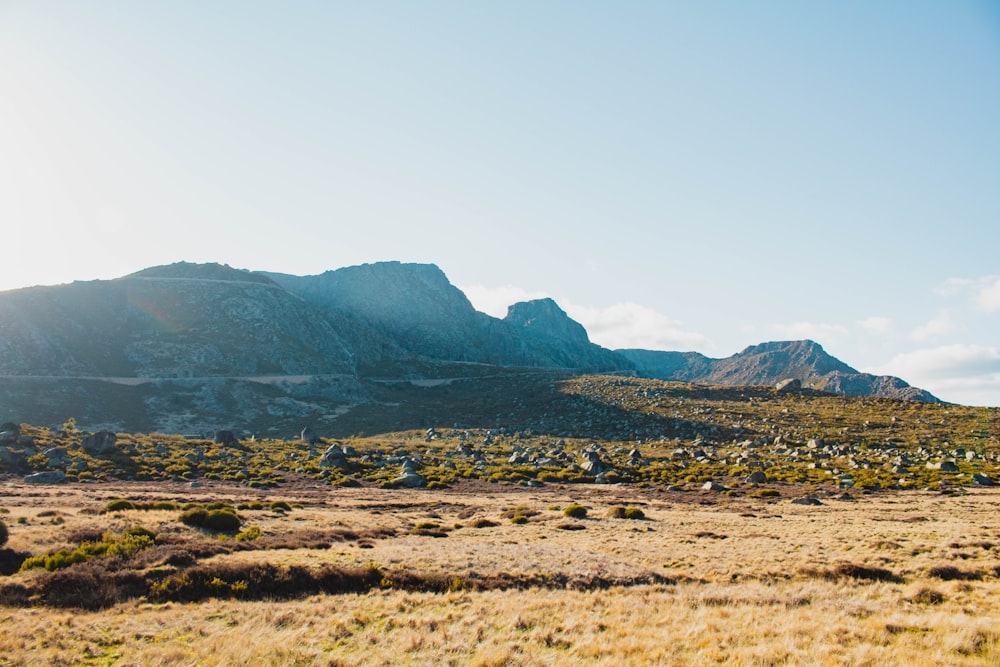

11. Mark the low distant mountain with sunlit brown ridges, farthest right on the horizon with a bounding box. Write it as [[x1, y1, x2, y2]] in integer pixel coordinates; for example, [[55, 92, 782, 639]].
[[617, 340, 940, 403]]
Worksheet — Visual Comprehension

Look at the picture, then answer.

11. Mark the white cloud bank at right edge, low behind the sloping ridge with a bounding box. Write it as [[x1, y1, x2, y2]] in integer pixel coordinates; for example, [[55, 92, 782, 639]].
[[866, 344, 1000, 406]]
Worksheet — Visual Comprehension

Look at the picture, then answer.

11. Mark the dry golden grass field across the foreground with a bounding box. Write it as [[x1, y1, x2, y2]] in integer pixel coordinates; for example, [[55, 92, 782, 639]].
[[0, 481, 1000, 666]]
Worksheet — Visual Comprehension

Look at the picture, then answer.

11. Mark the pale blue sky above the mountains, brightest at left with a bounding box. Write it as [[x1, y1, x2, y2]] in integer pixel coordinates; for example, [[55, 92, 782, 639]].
[[0, 0, 1000, 406]]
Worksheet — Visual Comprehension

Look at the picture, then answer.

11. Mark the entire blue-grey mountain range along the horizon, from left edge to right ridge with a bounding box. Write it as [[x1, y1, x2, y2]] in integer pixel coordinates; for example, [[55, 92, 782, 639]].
[[0, 262, 937, 432]]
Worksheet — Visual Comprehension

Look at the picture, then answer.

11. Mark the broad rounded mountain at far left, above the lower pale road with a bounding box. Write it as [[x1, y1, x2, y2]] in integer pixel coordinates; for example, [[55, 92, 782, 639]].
[[0, 263, 355, 378]]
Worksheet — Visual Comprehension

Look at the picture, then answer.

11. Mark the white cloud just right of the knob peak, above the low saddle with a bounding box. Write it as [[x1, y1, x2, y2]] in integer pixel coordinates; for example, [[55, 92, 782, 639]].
[[563, 302, 712, 351]]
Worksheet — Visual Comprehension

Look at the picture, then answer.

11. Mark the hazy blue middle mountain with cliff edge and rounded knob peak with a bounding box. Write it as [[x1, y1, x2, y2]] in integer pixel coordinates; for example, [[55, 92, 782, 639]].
[[262, 262, 631, 372]]
